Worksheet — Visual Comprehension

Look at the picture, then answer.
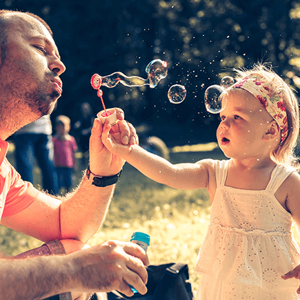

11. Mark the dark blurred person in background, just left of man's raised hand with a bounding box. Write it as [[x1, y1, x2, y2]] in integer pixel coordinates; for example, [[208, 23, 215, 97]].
[[74, 102, 95, 168]]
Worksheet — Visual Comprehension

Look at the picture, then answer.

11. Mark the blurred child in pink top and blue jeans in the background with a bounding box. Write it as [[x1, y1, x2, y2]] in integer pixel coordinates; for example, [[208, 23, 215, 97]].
[[53, 115, 77, 193]]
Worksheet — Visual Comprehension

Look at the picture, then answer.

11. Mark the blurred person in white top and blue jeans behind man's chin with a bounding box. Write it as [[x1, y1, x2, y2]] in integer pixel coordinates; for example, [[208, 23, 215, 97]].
[[13, 115, 58, 195]]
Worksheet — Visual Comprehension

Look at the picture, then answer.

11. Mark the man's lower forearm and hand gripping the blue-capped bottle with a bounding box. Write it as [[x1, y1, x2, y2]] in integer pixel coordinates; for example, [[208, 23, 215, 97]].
[[0, 241, 148, 300]]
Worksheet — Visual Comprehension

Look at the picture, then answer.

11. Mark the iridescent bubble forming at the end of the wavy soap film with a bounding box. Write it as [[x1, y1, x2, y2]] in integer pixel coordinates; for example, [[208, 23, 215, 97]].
[[146, 59, 168, 88]]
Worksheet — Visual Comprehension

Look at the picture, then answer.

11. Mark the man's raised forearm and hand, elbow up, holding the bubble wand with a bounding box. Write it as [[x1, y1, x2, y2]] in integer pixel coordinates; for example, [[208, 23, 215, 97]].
[[60, 110, 137, 242]]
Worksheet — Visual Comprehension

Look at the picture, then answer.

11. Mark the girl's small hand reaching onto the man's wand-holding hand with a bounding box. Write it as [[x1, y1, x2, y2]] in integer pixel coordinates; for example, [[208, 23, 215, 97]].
[[102, 120, 137, 156]]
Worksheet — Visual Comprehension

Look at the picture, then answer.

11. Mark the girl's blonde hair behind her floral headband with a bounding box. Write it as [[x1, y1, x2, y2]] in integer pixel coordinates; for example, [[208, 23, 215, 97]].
[[235, 64, 300, 169]]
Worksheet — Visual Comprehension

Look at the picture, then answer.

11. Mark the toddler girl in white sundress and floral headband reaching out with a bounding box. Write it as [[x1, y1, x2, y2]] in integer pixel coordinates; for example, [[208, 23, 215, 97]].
[[102, 65, 300, 300]]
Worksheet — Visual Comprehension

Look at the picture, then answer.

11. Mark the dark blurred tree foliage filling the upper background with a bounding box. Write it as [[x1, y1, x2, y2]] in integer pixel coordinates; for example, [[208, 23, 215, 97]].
[[2, 0, 300, 145]]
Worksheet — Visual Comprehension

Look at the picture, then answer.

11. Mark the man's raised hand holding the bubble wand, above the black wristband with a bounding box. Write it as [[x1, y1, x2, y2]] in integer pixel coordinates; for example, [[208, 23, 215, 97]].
[[90, 108, 138, 176]]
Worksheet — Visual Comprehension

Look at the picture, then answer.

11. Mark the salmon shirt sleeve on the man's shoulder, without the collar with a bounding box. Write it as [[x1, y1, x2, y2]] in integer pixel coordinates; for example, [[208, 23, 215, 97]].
[[2, 165, 41, 217]]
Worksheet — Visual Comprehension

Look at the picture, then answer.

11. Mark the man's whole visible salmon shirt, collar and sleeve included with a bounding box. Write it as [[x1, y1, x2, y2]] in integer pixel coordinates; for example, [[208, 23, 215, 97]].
[[0, 139, 40, 220]]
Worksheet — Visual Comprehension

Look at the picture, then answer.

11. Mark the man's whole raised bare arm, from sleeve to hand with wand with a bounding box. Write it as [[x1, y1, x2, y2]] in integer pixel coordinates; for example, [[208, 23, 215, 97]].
[[1, 110, 137, 243]]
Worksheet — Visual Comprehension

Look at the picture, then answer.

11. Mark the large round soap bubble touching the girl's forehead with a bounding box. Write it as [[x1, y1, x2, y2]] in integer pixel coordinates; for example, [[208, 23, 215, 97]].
[[204, 84, 225, 114]]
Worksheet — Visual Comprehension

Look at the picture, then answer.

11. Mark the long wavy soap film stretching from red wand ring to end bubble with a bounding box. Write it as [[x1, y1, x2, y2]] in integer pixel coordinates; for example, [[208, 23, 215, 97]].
[[91, 59, 168, 90]]
